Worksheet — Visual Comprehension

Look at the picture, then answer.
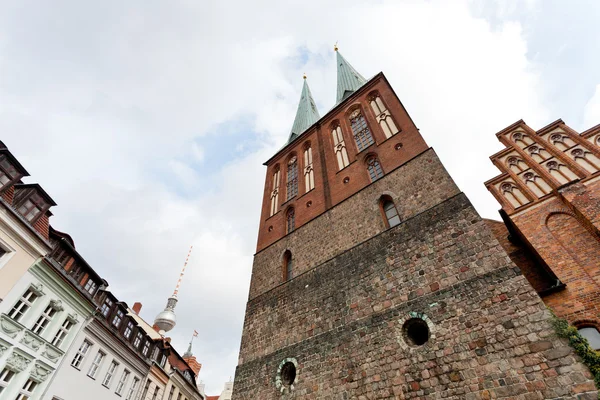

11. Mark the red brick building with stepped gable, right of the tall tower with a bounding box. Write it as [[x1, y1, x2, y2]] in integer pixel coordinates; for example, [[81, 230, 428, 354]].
[[485, 120, 600, 349]]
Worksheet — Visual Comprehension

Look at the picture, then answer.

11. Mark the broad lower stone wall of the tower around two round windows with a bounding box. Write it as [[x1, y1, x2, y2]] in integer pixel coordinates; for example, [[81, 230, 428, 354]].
[[233, 194, 596, 400]]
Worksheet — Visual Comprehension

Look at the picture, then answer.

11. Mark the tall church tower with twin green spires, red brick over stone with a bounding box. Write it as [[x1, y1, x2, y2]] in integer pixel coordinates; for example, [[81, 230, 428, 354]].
[[233, 48, 597, 400]]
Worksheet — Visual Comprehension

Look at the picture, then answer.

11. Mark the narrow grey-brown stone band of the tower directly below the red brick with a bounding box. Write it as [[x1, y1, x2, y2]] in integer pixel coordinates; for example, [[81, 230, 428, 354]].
[[249, 149, 459, 299]]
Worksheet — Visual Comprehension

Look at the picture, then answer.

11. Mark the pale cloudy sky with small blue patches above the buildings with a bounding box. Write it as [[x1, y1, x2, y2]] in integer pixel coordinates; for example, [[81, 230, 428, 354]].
[[0, 0, 600, 394]]
